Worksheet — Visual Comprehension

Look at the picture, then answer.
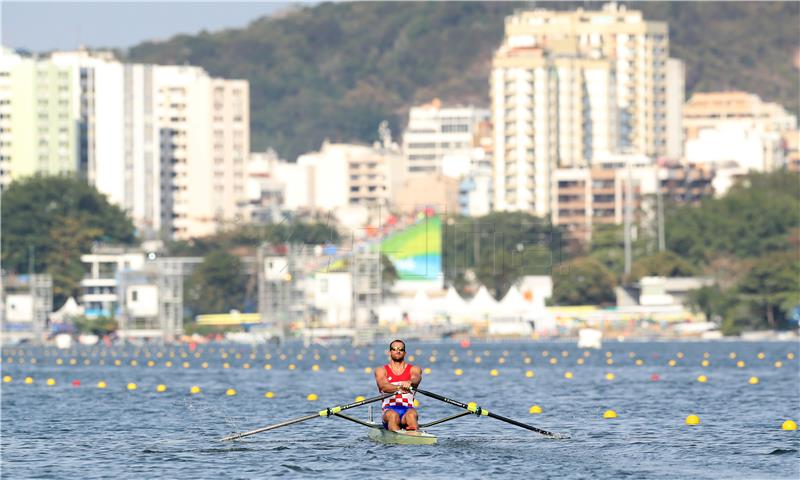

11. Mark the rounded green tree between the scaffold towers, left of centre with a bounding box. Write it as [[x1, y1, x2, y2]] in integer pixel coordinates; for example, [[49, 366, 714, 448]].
[[186, 251, 246, 315]]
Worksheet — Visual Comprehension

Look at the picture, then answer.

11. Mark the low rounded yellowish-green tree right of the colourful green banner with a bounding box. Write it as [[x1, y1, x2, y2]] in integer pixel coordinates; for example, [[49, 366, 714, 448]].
[[553, 257, 616, 305]]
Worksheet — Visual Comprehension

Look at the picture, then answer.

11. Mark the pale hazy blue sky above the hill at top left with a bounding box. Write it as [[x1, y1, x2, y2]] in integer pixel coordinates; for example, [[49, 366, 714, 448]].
[[0, 0, 308, 52]]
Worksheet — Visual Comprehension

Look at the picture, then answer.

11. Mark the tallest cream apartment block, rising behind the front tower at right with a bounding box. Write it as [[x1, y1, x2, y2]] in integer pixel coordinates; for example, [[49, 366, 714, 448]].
[[505, 3, 682, 157]]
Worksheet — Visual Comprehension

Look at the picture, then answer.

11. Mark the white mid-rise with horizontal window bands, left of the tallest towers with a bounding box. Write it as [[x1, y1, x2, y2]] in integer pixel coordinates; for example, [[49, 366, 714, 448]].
[[403, 99, 489, 176]]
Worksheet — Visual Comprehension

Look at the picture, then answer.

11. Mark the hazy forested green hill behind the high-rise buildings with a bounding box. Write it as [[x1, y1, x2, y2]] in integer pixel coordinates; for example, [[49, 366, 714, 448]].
[[126, 2, 800, 159]]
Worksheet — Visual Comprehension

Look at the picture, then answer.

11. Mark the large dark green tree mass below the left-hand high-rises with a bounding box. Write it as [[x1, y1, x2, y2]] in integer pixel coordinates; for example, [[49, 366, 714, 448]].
[[0, 176, 134, 307]]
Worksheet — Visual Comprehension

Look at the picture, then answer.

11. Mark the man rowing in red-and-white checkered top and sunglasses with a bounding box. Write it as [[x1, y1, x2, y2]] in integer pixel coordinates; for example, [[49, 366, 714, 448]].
[[375, 340, 422, 431]]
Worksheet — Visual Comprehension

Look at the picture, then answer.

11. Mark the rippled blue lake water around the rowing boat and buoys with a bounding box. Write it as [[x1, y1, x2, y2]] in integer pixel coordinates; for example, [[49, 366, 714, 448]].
[[0, 342, 800, 479]]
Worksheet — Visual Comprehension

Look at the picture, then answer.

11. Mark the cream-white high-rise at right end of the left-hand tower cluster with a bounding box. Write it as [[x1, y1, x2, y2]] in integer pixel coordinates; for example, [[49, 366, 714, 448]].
[[153, 66, 250, 239]]
